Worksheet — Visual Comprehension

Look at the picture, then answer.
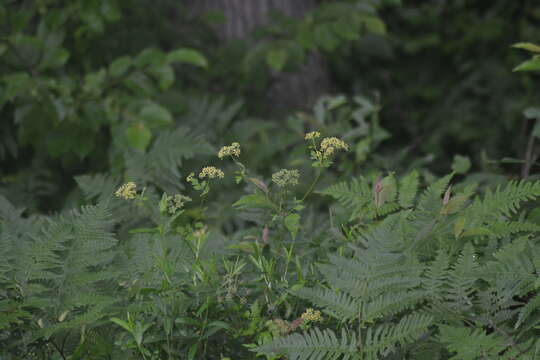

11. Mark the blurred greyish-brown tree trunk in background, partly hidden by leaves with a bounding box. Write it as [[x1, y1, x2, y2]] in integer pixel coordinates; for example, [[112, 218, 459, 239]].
[[190, 0, 331, 113]]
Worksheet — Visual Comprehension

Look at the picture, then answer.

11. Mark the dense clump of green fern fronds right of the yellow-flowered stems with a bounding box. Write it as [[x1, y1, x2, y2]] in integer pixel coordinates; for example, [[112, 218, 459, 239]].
[[257, 173, 540, 359]]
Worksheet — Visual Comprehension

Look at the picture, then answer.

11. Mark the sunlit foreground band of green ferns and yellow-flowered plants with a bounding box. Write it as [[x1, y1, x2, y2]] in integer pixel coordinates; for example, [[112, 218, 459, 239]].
[[0, 132, 540, 359]]
